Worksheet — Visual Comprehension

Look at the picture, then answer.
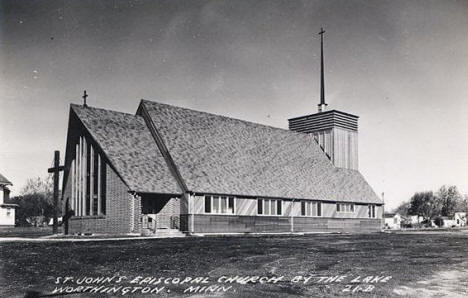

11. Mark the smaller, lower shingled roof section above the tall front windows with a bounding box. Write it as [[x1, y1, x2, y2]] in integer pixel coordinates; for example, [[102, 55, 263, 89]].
[[71, 104, 181, 194]]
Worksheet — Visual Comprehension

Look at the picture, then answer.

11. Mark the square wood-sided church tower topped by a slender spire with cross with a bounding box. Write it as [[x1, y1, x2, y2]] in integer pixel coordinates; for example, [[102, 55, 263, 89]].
[[288, 28, 359, 170]]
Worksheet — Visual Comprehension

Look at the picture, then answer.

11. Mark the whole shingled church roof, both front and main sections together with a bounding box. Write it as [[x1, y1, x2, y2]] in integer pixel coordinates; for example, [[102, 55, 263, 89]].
[[71, 100, 382, 204]]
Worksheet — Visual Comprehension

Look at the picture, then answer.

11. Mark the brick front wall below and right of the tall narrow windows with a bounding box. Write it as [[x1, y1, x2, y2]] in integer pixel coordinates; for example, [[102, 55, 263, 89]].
[[68, 166, 136, 234]]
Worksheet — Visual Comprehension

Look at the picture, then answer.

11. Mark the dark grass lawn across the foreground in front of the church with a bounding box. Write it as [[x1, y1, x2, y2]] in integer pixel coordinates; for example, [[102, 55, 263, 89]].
[[0, 232, 468, 297]]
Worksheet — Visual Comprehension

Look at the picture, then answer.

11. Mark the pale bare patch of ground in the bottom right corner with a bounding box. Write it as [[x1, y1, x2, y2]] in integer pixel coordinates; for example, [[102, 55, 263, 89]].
[[393, 262, 468, 298]]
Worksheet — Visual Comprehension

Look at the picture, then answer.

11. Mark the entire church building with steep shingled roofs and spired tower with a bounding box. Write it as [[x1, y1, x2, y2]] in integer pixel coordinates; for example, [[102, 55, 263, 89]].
[[62, 30, 383, 235]]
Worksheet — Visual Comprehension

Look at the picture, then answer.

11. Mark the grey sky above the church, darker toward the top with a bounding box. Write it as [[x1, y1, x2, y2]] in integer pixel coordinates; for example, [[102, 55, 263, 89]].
[[0, 0, 468, 209]]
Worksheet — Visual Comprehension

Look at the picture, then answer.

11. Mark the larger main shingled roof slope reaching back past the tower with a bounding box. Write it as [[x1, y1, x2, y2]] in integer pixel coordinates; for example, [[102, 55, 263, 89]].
[[141, 100, 382, 204]]
